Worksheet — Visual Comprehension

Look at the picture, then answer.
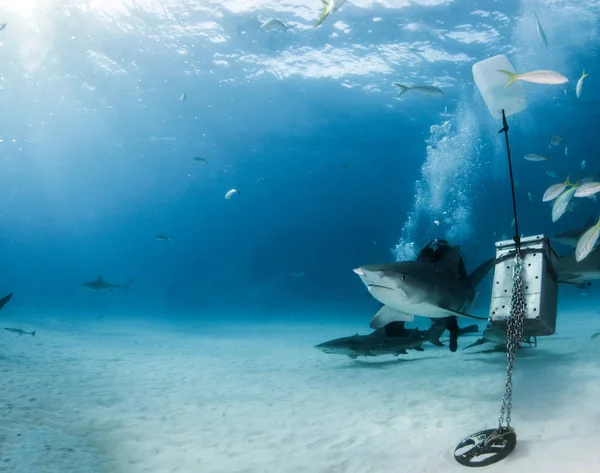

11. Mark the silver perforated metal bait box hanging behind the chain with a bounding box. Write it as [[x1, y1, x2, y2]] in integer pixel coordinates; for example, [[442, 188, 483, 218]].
[[490, 235, 558, 337]]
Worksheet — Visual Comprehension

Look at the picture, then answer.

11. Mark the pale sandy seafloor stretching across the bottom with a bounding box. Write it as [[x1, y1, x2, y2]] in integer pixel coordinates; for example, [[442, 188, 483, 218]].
[[0, 305, 600, 473]]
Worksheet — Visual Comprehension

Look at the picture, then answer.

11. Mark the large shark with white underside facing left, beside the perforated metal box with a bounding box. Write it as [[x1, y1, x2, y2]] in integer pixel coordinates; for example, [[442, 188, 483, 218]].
[[354, 246, 495, 329]]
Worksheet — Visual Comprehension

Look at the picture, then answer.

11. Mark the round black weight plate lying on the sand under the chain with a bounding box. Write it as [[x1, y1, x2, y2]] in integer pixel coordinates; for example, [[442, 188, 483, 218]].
[[454, 427, 517, 467]]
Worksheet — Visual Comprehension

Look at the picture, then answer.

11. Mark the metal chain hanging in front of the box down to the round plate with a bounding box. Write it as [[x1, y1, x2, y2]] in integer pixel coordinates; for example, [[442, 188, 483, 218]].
[[498, 249, 525, 428]]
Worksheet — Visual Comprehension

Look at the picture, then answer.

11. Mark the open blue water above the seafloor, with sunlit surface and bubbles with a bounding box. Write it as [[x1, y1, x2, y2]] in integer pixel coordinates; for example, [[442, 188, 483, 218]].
[[0, 0, 600, 471]]
